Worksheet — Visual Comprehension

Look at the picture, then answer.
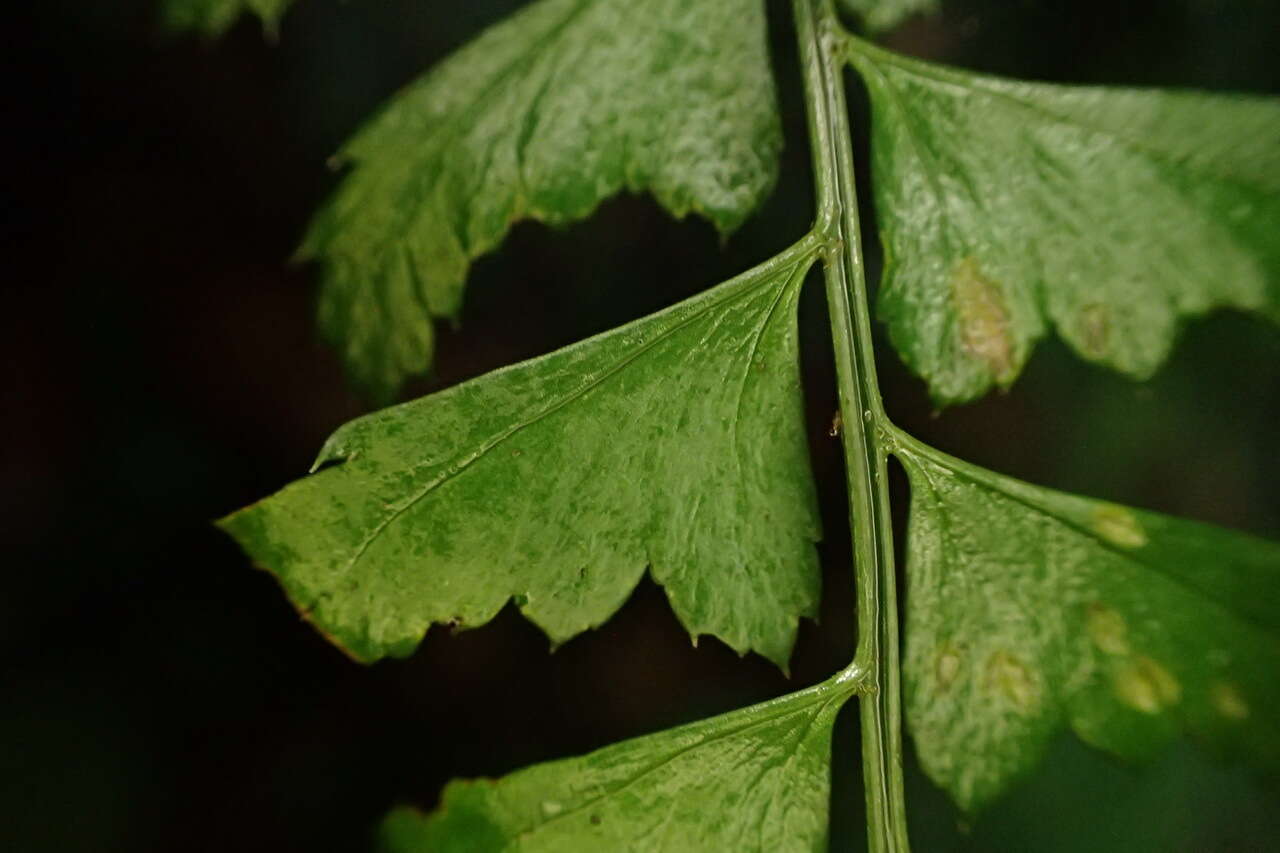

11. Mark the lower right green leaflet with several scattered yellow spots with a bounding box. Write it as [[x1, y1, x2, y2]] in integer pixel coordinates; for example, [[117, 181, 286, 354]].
[[899, 439, 1280, 811]]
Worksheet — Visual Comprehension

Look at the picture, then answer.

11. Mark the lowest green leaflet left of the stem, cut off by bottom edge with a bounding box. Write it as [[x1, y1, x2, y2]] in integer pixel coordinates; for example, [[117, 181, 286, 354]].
[[381, 680, 852, 853]]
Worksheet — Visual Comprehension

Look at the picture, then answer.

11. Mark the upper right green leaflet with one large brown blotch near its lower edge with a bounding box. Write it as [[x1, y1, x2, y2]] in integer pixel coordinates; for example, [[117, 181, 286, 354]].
[[850, 40, 1280, 403]]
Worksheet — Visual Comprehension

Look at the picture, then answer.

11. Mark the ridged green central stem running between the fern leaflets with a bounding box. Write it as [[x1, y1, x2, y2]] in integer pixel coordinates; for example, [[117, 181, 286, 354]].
[[792, 0, 909, 853]]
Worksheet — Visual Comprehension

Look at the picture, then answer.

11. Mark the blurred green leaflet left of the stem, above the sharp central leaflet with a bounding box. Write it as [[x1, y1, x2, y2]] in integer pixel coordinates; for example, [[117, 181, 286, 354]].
[[300, 0, 781, 400]]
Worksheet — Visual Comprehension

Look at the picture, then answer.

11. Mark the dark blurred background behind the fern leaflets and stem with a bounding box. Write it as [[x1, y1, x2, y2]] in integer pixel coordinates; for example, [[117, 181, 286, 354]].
[[0, 0, 1280, 853]]
